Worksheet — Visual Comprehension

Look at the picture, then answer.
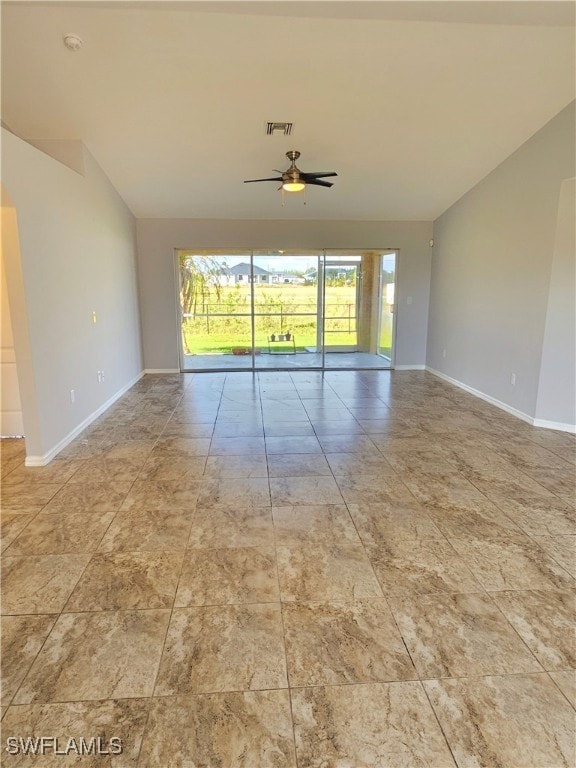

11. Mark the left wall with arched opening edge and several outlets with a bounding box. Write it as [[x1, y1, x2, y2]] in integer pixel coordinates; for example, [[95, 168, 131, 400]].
[[2, 130, 142, 463]]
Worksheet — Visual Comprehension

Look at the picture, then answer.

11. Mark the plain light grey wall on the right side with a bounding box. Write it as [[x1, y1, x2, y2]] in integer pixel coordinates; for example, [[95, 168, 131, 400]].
[[427, 103, 575, 426]]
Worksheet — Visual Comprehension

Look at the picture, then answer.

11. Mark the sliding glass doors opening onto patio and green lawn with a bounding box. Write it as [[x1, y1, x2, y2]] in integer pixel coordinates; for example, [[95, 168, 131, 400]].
[[176, 249, 397, 372]]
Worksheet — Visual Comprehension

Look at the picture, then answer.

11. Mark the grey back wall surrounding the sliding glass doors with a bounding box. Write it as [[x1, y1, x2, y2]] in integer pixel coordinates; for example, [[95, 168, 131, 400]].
[[137, 219, 432, 370]]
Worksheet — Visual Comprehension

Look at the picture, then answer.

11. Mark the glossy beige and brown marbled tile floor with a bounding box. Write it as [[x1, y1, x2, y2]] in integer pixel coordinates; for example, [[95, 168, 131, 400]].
[[2, 371, 576, 768]]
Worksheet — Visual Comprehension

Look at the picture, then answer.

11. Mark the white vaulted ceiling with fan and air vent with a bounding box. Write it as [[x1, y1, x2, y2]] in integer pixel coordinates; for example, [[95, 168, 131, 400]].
[[2, 0, 575, 220]]
